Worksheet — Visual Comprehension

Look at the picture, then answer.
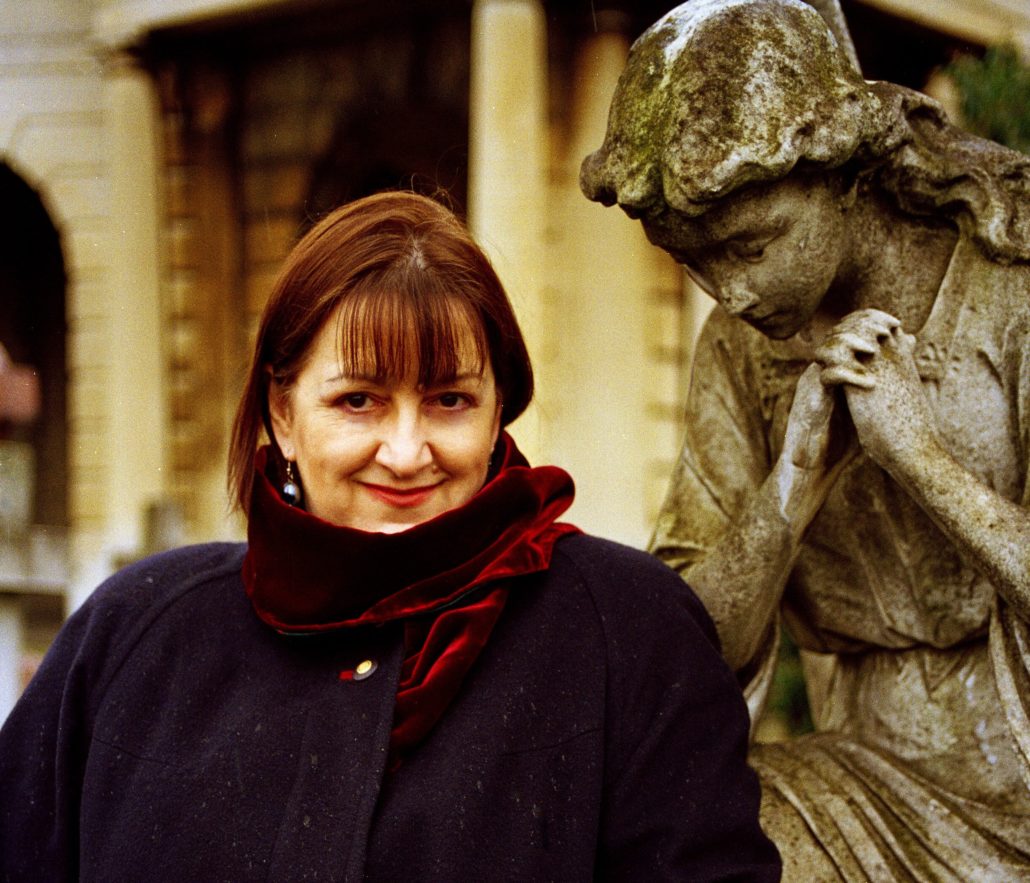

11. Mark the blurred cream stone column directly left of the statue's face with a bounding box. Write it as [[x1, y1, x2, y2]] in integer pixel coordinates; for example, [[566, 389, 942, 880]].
[[551, 17, 683, 546]]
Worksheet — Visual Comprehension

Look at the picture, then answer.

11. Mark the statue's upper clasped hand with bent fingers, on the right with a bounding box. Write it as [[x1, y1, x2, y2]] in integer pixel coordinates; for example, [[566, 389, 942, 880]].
[[816, 309, 939, 477]]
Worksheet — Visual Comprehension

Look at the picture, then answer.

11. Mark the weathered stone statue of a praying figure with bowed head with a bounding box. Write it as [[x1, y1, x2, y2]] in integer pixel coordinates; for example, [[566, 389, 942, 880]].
[[581, 0, 1030, 881]]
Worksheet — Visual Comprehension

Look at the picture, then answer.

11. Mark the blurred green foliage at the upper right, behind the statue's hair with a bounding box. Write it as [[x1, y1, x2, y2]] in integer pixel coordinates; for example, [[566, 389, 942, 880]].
[[946, 46, 1030, 154]]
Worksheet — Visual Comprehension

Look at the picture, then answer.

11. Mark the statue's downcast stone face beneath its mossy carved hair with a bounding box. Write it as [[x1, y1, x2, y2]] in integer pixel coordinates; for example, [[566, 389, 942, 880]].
[[642, 175, 848, 339]]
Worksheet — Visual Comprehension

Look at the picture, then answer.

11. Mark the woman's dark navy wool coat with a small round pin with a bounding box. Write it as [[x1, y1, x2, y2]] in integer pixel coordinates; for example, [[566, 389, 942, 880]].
[[0, 536, 779, 883]]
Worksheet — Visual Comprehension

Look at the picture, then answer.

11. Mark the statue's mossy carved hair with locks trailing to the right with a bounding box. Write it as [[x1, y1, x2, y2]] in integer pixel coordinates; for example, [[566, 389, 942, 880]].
[[580, 0, 1030, 261]]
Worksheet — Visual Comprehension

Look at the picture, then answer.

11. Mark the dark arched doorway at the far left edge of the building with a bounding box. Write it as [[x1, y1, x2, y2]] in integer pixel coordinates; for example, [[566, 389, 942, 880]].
[[0, 161, 68, 720]]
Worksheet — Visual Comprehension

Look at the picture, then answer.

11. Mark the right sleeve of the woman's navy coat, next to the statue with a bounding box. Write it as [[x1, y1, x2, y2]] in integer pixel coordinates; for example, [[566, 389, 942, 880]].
[[597, 548, 780, 883]]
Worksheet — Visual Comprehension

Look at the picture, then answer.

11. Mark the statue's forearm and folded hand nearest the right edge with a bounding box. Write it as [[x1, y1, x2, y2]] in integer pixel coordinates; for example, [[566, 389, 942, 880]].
[[819, 310, 1030, 619]]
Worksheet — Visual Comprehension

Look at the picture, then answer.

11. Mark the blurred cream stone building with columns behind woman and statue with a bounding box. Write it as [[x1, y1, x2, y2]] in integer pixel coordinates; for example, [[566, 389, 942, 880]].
[[0, 0, 1030, 717]]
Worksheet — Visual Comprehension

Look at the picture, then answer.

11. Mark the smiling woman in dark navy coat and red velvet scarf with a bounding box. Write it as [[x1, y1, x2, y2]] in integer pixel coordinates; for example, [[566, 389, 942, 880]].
[[0, 193, 779, 881]]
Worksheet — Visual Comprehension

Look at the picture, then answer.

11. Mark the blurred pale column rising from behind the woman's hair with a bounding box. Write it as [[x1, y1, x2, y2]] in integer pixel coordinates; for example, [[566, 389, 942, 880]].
[[469, 0, 548, 463]]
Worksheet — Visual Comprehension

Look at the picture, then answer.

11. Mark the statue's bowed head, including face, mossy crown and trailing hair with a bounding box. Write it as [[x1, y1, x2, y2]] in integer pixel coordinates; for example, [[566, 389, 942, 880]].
[[580, 0, 1030, 338]]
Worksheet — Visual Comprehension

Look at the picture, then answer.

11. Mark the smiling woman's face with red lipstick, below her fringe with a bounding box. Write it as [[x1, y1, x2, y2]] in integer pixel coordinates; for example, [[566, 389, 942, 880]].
[[270, 307, 501, 534]]
